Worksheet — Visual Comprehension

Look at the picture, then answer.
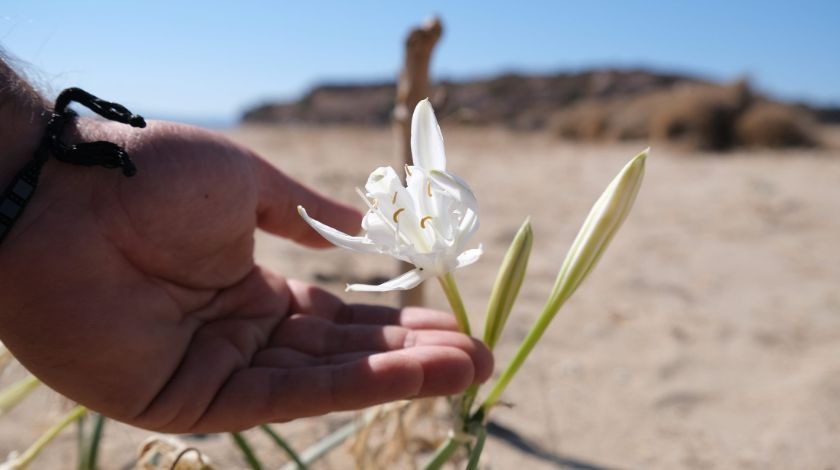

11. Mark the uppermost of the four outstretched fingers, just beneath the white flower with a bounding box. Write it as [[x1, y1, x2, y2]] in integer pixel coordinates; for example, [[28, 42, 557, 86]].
[[287, 279, 458, 331]]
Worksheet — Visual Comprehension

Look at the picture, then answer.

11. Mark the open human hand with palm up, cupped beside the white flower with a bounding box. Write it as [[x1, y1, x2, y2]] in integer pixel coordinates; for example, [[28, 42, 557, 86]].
[[0, 120, 492, 432]]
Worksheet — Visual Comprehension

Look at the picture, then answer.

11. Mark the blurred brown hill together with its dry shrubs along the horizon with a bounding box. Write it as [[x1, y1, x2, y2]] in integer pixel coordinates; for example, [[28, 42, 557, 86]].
[[242, 69, 840, 150]]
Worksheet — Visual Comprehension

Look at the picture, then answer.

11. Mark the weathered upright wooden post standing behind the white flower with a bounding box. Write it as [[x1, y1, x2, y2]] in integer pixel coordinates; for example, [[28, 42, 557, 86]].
[[393, 18, 443, 307]]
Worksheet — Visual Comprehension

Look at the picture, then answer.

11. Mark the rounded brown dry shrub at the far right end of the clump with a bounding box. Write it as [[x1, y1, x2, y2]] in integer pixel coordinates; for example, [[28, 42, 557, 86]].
[[735, 101, 817, 148]]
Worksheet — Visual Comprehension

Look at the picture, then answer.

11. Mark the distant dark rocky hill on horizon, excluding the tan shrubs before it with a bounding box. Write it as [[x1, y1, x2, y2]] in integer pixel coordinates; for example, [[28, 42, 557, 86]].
[[242, 70, 704, 129]]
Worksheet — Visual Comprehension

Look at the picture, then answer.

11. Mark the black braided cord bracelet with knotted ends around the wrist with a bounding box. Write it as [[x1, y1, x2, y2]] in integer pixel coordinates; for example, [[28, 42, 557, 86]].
[[0, 88, 146, 242]]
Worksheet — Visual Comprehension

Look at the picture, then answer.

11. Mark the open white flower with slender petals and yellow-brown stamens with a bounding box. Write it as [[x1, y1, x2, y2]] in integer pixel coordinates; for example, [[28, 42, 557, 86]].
[[298, 99, 482, 291]]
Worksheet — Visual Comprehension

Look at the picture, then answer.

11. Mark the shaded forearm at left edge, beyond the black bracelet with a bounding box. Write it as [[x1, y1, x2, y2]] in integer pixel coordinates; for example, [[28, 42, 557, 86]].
[[0, 54, 49, 185]]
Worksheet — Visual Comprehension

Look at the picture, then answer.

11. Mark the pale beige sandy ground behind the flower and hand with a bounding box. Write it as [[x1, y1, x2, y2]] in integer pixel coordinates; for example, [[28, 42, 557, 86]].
[[0, 123, 840, 470]]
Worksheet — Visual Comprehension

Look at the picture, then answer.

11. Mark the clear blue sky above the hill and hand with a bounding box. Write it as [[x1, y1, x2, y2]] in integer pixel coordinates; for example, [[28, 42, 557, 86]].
[[0, 0, 840, 120]]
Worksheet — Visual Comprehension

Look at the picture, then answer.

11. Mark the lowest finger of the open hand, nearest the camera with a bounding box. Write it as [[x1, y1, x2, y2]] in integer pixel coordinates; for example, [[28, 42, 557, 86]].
[[190, 347, 476, 432]]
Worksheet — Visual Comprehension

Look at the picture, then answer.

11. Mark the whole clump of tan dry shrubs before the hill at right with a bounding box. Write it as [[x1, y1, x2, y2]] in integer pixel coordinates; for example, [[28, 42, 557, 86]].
[[550, 81, 817, 151]]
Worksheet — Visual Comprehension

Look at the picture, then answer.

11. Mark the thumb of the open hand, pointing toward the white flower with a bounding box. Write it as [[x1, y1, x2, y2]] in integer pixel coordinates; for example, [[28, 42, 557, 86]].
[[254, 157, 362, 247]]
